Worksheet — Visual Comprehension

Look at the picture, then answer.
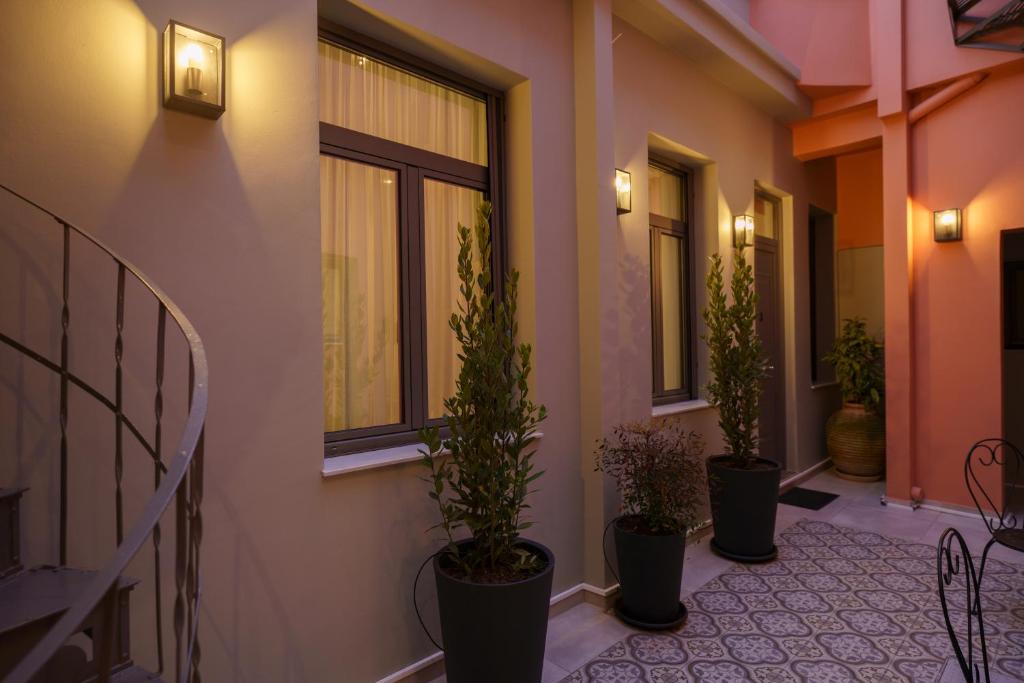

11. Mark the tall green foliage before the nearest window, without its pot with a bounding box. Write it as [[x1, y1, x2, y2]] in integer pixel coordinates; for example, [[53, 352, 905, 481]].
[[420, 203, 547, 583]]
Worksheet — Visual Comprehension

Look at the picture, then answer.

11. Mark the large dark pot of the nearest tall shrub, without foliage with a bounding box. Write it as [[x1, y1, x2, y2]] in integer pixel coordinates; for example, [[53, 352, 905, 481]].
[[434, 540, 555, 683]]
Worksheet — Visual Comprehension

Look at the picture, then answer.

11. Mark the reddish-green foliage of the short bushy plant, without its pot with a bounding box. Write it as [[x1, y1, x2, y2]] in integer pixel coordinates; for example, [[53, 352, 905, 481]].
[[595, 421, 705, 535]]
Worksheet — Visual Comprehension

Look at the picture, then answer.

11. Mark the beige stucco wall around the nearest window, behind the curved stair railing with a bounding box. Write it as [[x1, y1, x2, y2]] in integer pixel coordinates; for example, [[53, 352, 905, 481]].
[[0, 0, 582, 681]]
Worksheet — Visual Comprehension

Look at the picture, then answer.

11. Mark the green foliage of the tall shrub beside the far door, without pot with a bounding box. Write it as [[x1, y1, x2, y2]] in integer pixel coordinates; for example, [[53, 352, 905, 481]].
[[703, 249, 768, 468]]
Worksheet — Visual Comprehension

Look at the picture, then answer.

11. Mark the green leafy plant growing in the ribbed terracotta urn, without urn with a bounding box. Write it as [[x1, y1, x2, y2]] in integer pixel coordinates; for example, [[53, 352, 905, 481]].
[[825, 317, 886, 413]]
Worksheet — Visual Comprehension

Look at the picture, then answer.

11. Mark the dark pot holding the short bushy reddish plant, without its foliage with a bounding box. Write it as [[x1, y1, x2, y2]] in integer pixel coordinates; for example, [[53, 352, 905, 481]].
[[613, 517, 686, 630]]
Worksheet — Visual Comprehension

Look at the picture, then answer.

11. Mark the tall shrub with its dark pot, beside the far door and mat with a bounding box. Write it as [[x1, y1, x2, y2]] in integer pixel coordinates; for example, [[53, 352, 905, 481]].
[[703, 249, 781, 562]]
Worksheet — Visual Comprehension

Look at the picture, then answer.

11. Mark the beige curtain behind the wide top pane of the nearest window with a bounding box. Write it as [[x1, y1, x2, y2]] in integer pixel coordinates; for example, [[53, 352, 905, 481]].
[[319, 41, 487, 165]]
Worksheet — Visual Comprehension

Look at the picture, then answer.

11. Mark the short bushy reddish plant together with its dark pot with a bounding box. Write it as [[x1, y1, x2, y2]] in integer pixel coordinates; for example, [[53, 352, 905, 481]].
[[596, 421, 705, 629]]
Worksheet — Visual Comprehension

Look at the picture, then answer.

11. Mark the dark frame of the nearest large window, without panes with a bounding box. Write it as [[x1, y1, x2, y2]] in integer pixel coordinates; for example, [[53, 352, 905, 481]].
[[318, 18, 508, 458]]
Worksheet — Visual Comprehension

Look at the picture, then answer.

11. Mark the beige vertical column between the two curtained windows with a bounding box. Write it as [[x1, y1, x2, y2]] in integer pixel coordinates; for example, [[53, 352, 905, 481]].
[[572, 0, 620, 588]]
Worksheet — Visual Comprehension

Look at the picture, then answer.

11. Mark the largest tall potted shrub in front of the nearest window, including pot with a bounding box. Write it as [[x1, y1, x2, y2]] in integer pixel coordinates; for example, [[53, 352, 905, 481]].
[[420, 204, 555, 683]]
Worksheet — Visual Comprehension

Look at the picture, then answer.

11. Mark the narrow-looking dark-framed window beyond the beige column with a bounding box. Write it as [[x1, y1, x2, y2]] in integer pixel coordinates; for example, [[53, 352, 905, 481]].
[[647, 160, 693, 404]]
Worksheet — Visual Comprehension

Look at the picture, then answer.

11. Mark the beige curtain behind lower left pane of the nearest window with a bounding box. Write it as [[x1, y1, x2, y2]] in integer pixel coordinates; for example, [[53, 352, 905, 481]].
[[321, 155, 401, 431]]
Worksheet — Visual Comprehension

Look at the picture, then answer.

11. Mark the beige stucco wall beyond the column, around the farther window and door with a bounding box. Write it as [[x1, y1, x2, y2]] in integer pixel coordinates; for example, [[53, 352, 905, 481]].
[[613, 20, 837, 470]]
